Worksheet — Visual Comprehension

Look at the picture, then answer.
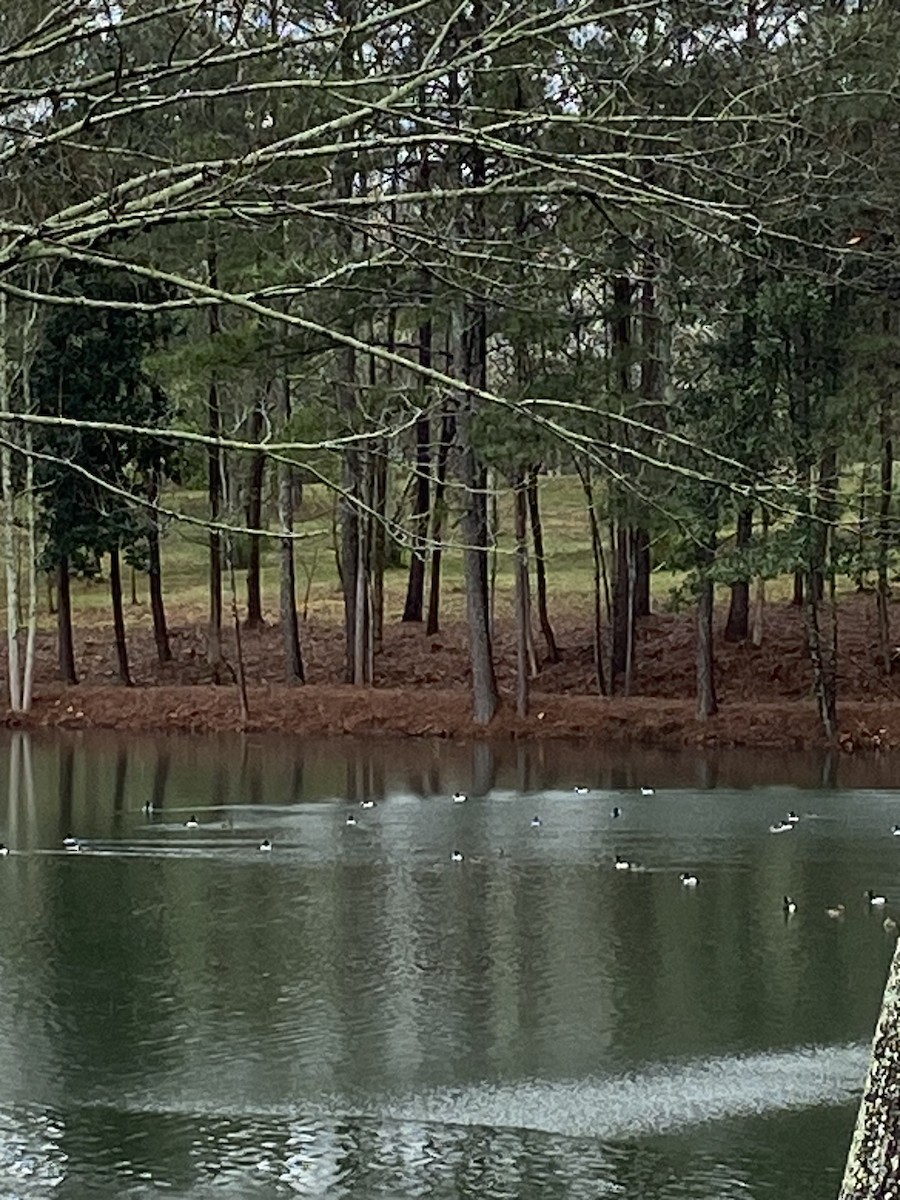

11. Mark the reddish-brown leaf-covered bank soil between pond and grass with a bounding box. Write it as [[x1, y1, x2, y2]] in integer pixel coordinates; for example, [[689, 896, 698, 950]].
[[0, 595, 900, 752]]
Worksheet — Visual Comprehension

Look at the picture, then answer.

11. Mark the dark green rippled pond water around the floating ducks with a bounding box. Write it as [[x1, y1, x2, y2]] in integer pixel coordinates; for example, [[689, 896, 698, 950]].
[[0, 736, 900, 1200]]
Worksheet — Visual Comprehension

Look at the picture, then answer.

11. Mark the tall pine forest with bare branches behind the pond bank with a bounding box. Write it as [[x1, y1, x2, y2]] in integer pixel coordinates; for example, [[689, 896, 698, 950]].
[[0, 0, 900, 740]]
